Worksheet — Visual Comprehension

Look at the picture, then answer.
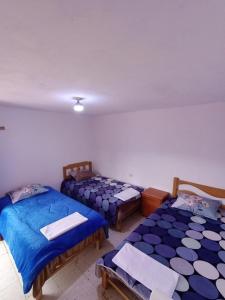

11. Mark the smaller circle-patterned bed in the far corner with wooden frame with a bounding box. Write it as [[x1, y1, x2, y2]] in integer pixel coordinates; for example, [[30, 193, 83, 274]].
[[61, 161, 143, 230]]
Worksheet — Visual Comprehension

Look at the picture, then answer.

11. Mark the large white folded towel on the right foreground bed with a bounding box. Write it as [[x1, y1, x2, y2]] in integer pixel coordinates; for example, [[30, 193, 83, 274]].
[[112, 243, 179, 298]]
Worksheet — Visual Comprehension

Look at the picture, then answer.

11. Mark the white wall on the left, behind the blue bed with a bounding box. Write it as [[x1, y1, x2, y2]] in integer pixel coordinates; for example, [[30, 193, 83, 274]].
[[0, 106, 90, 195]]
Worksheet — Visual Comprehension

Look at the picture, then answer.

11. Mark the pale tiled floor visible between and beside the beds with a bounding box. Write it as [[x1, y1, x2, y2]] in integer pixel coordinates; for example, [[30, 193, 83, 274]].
[[0, 213, 142, 300]]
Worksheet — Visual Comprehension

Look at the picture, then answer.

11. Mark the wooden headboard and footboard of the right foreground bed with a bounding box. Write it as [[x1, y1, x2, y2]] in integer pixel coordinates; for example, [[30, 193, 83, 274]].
[[101, 177, 225, 300]]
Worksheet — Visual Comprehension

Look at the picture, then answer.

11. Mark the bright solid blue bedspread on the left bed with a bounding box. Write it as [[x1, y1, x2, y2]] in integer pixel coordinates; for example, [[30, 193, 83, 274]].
[[0, 187, 107, 293]]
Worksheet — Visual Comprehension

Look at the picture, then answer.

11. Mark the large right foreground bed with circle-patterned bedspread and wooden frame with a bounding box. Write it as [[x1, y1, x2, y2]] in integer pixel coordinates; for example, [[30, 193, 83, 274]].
[[96, 178, 225, 300]]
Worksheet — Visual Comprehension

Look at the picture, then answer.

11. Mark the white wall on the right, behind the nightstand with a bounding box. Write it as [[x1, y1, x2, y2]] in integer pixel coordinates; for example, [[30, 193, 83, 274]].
[[92, 103, 225, 191]]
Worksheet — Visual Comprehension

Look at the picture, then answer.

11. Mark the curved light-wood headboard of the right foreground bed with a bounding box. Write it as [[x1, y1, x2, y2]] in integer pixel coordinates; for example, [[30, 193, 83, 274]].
[[172, 177, 225, 208]]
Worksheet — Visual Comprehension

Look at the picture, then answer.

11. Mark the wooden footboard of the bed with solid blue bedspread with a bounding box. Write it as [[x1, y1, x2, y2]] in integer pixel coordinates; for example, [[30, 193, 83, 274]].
[[33, 228, 105, 300]]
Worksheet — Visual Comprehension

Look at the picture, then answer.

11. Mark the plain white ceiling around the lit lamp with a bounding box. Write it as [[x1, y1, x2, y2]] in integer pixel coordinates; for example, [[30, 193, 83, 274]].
[[0, 0, 225, 114]]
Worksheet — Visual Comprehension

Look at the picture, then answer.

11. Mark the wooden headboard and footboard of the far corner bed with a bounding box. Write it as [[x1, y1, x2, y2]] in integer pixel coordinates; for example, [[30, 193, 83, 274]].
[[63, 161, 141, 231]]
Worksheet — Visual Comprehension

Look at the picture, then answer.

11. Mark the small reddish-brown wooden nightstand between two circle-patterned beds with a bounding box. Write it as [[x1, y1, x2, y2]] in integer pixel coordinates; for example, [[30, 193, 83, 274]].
[[141, 188, 169, 217]]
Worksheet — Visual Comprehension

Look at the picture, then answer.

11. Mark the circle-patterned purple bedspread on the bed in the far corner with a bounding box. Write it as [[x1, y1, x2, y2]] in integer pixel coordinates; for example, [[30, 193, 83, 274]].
[[61, 176, 143, 225]]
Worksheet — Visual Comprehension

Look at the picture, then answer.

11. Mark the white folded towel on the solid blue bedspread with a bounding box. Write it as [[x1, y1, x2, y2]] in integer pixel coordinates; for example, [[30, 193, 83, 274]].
[[40, 212, 88, 241]]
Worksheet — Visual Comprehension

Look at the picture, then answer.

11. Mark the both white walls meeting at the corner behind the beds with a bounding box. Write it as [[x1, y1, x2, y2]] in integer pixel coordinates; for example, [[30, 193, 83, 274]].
[[0, 103, 225, 195]]
